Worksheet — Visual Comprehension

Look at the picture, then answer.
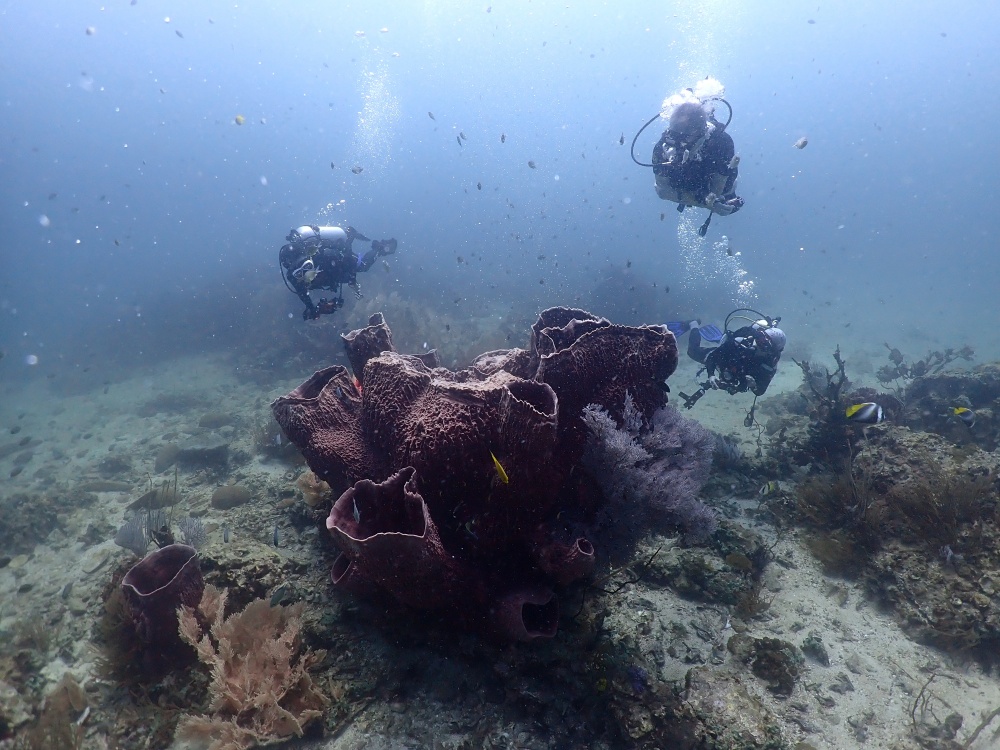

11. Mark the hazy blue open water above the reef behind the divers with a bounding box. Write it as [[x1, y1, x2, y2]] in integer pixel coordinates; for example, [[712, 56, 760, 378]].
[[0, 0, 1000, 382]]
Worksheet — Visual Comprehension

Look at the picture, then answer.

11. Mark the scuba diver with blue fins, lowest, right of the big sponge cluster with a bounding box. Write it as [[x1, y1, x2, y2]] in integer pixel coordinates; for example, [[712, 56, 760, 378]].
[[667, 308, 785, 424]]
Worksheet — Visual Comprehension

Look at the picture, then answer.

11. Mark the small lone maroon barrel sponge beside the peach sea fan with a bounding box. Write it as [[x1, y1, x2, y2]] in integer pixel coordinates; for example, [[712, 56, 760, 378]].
[[121, 544, 205, 646]]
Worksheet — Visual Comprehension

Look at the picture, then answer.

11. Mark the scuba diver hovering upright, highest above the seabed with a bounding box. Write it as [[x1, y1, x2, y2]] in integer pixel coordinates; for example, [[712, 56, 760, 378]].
[[632, 78, 743, 237]]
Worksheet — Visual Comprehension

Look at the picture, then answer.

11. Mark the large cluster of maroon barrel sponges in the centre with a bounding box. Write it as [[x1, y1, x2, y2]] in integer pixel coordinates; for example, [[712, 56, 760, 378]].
[[272, 308, 677, 640]]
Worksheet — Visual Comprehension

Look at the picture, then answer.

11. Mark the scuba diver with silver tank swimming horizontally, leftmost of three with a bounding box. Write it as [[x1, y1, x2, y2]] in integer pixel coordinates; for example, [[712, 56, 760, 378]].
[[278, 225, 396, 320]]
